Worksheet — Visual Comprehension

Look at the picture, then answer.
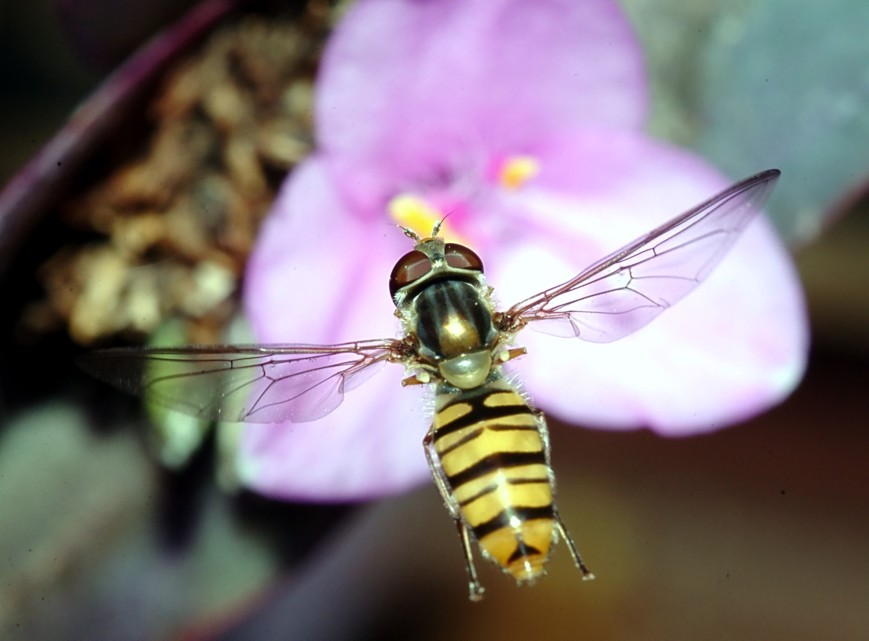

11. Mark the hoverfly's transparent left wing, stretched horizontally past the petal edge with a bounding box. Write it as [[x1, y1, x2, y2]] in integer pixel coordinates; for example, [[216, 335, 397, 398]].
[[81, 339, 404, 423]]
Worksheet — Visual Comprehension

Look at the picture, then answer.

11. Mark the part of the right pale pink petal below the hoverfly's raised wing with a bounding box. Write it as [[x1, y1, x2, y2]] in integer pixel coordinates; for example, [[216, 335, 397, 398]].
[[522, 221, 808, 435]]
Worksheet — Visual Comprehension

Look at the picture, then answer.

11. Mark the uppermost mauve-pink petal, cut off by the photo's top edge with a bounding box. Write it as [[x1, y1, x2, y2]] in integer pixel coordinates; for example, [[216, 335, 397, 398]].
[[317, 0, 646, 210]]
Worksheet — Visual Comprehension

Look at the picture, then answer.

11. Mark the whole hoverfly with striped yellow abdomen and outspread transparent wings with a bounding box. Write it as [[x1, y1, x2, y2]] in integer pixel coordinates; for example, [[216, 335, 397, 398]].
[[83, 169, 779, 601]]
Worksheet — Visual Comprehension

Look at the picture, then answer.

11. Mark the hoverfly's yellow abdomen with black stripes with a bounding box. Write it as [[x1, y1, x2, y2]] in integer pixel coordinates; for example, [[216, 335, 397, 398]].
[[431, 380, 555, 582]]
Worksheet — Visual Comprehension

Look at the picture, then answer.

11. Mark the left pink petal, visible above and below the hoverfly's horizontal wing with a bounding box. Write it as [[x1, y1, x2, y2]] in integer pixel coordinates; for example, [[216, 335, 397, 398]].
[[239, 159, 429, 501]]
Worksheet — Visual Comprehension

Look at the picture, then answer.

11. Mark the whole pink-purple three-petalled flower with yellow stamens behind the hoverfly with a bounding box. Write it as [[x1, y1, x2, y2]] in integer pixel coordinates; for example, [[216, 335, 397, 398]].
[[240, 0, 808, 500]]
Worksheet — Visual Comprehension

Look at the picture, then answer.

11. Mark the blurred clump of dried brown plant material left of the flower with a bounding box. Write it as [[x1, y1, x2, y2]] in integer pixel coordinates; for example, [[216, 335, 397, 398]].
[[23, 2, 331, 344]]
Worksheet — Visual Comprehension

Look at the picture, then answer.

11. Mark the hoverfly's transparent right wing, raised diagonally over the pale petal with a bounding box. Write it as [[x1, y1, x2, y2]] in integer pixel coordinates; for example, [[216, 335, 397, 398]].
[[504, 169, 780, 343]]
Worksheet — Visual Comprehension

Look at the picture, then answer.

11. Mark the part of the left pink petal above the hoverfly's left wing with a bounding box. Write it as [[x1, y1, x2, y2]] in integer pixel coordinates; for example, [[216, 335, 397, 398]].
[[245, 158, 396, 343]]
